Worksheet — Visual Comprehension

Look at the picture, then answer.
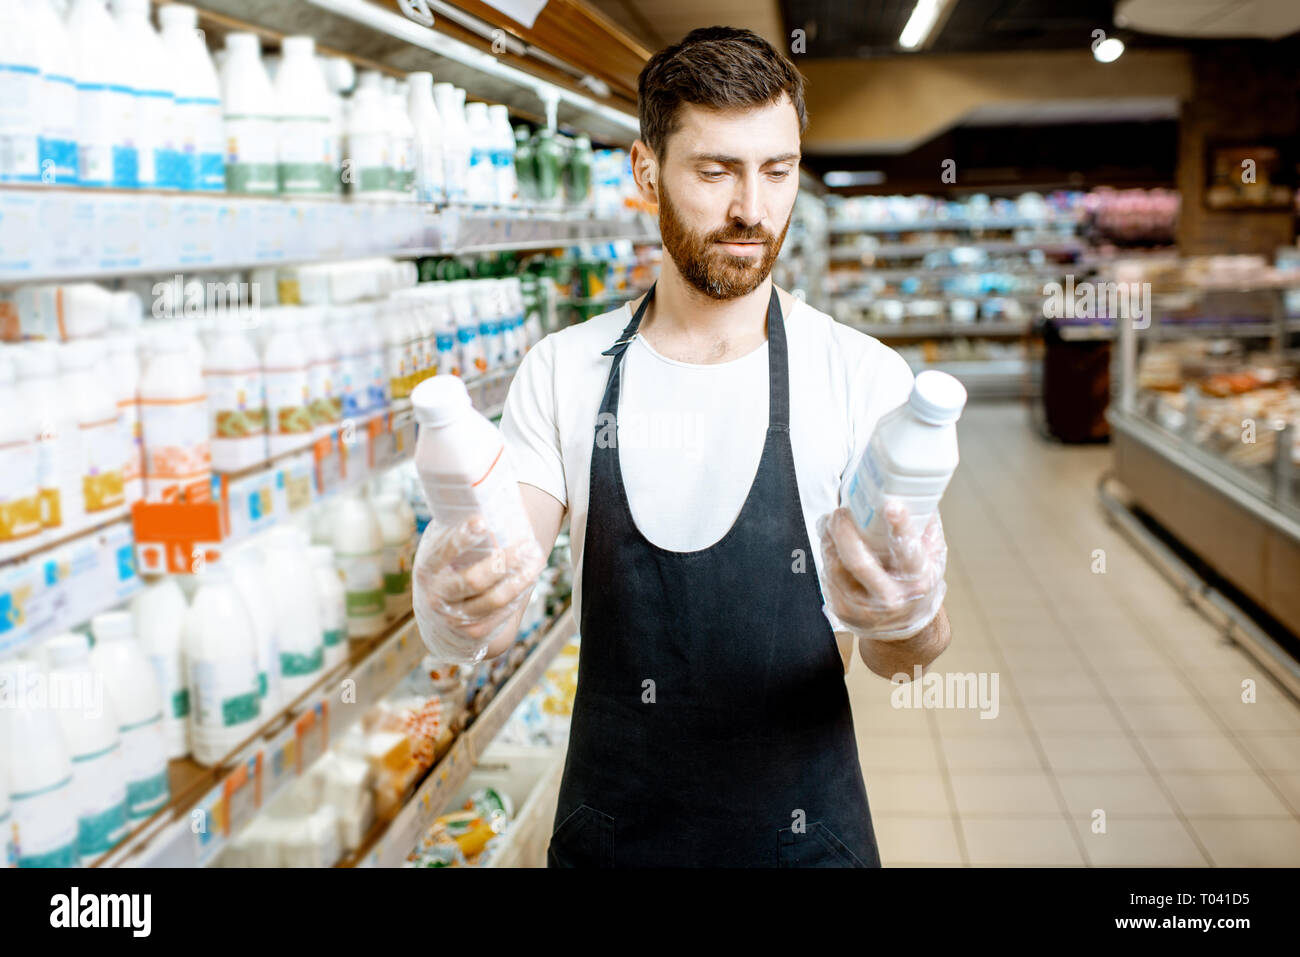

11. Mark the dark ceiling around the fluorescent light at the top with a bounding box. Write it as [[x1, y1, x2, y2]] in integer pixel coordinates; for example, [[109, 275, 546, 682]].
[[780, 0, 1187, 57]]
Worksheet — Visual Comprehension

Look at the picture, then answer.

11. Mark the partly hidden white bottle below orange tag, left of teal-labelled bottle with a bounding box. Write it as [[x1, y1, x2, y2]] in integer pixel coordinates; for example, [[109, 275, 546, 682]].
[[131, 577, 190, 758]]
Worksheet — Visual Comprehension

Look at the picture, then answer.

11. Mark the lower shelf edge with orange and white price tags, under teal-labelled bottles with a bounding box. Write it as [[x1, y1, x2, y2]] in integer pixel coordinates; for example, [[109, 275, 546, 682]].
[[96, 615, 424, 867]]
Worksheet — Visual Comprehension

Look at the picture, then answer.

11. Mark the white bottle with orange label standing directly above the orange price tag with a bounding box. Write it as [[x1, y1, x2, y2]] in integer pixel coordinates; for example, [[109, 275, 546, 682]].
[[140, 329, 212, 502]]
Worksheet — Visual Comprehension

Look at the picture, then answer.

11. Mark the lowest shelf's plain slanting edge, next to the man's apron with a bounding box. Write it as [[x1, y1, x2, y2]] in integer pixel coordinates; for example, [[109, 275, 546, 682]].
[[342, 606, 577, 867]]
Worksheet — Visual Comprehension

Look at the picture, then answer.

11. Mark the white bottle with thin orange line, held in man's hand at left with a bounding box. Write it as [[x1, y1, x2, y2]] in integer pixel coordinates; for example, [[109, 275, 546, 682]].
[[411, 376, 533, 564]]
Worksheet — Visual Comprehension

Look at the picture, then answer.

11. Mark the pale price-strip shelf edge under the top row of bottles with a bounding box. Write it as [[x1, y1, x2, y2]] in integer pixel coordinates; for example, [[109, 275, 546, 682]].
[[0, 186, 659, 285]]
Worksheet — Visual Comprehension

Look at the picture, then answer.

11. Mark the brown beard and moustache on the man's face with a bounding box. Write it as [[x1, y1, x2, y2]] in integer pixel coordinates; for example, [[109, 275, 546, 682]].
[[659, 180, 790, 299]]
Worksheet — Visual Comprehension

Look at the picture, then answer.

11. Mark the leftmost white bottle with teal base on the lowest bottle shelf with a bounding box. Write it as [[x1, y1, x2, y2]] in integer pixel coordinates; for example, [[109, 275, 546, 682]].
[[0, 661, 78, 867]]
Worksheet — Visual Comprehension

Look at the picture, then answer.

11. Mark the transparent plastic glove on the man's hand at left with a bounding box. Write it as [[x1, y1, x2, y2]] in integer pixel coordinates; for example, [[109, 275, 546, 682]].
[[412, 516, 546, 664]]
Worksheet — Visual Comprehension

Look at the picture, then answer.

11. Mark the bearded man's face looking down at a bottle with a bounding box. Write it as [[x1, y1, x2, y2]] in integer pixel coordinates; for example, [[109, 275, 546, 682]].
[[657, 96, 800, 299]]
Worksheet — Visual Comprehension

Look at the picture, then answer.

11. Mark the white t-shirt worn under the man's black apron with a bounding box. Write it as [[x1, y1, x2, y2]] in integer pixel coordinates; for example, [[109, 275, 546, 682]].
[[501, 300, 913, 631]]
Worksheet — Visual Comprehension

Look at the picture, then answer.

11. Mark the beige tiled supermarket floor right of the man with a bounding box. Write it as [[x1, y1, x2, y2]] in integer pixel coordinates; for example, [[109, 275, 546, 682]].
[[849, 404, 1300, 866]]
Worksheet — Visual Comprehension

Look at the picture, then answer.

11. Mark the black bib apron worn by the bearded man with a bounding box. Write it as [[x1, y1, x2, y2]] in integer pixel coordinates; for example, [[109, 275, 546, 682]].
[[547, 286, 880, 867]]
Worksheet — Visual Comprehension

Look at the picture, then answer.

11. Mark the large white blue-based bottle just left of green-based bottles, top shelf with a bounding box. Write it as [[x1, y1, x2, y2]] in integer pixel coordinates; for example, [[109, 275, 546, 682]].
[[159, 4, 226, 192]]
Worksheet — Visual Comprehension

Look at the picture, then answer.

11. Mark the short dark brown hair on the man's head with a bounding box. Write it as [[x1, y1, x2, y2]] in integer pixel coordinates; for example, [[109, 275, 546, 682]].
[[637, 26, 809, 159]]
